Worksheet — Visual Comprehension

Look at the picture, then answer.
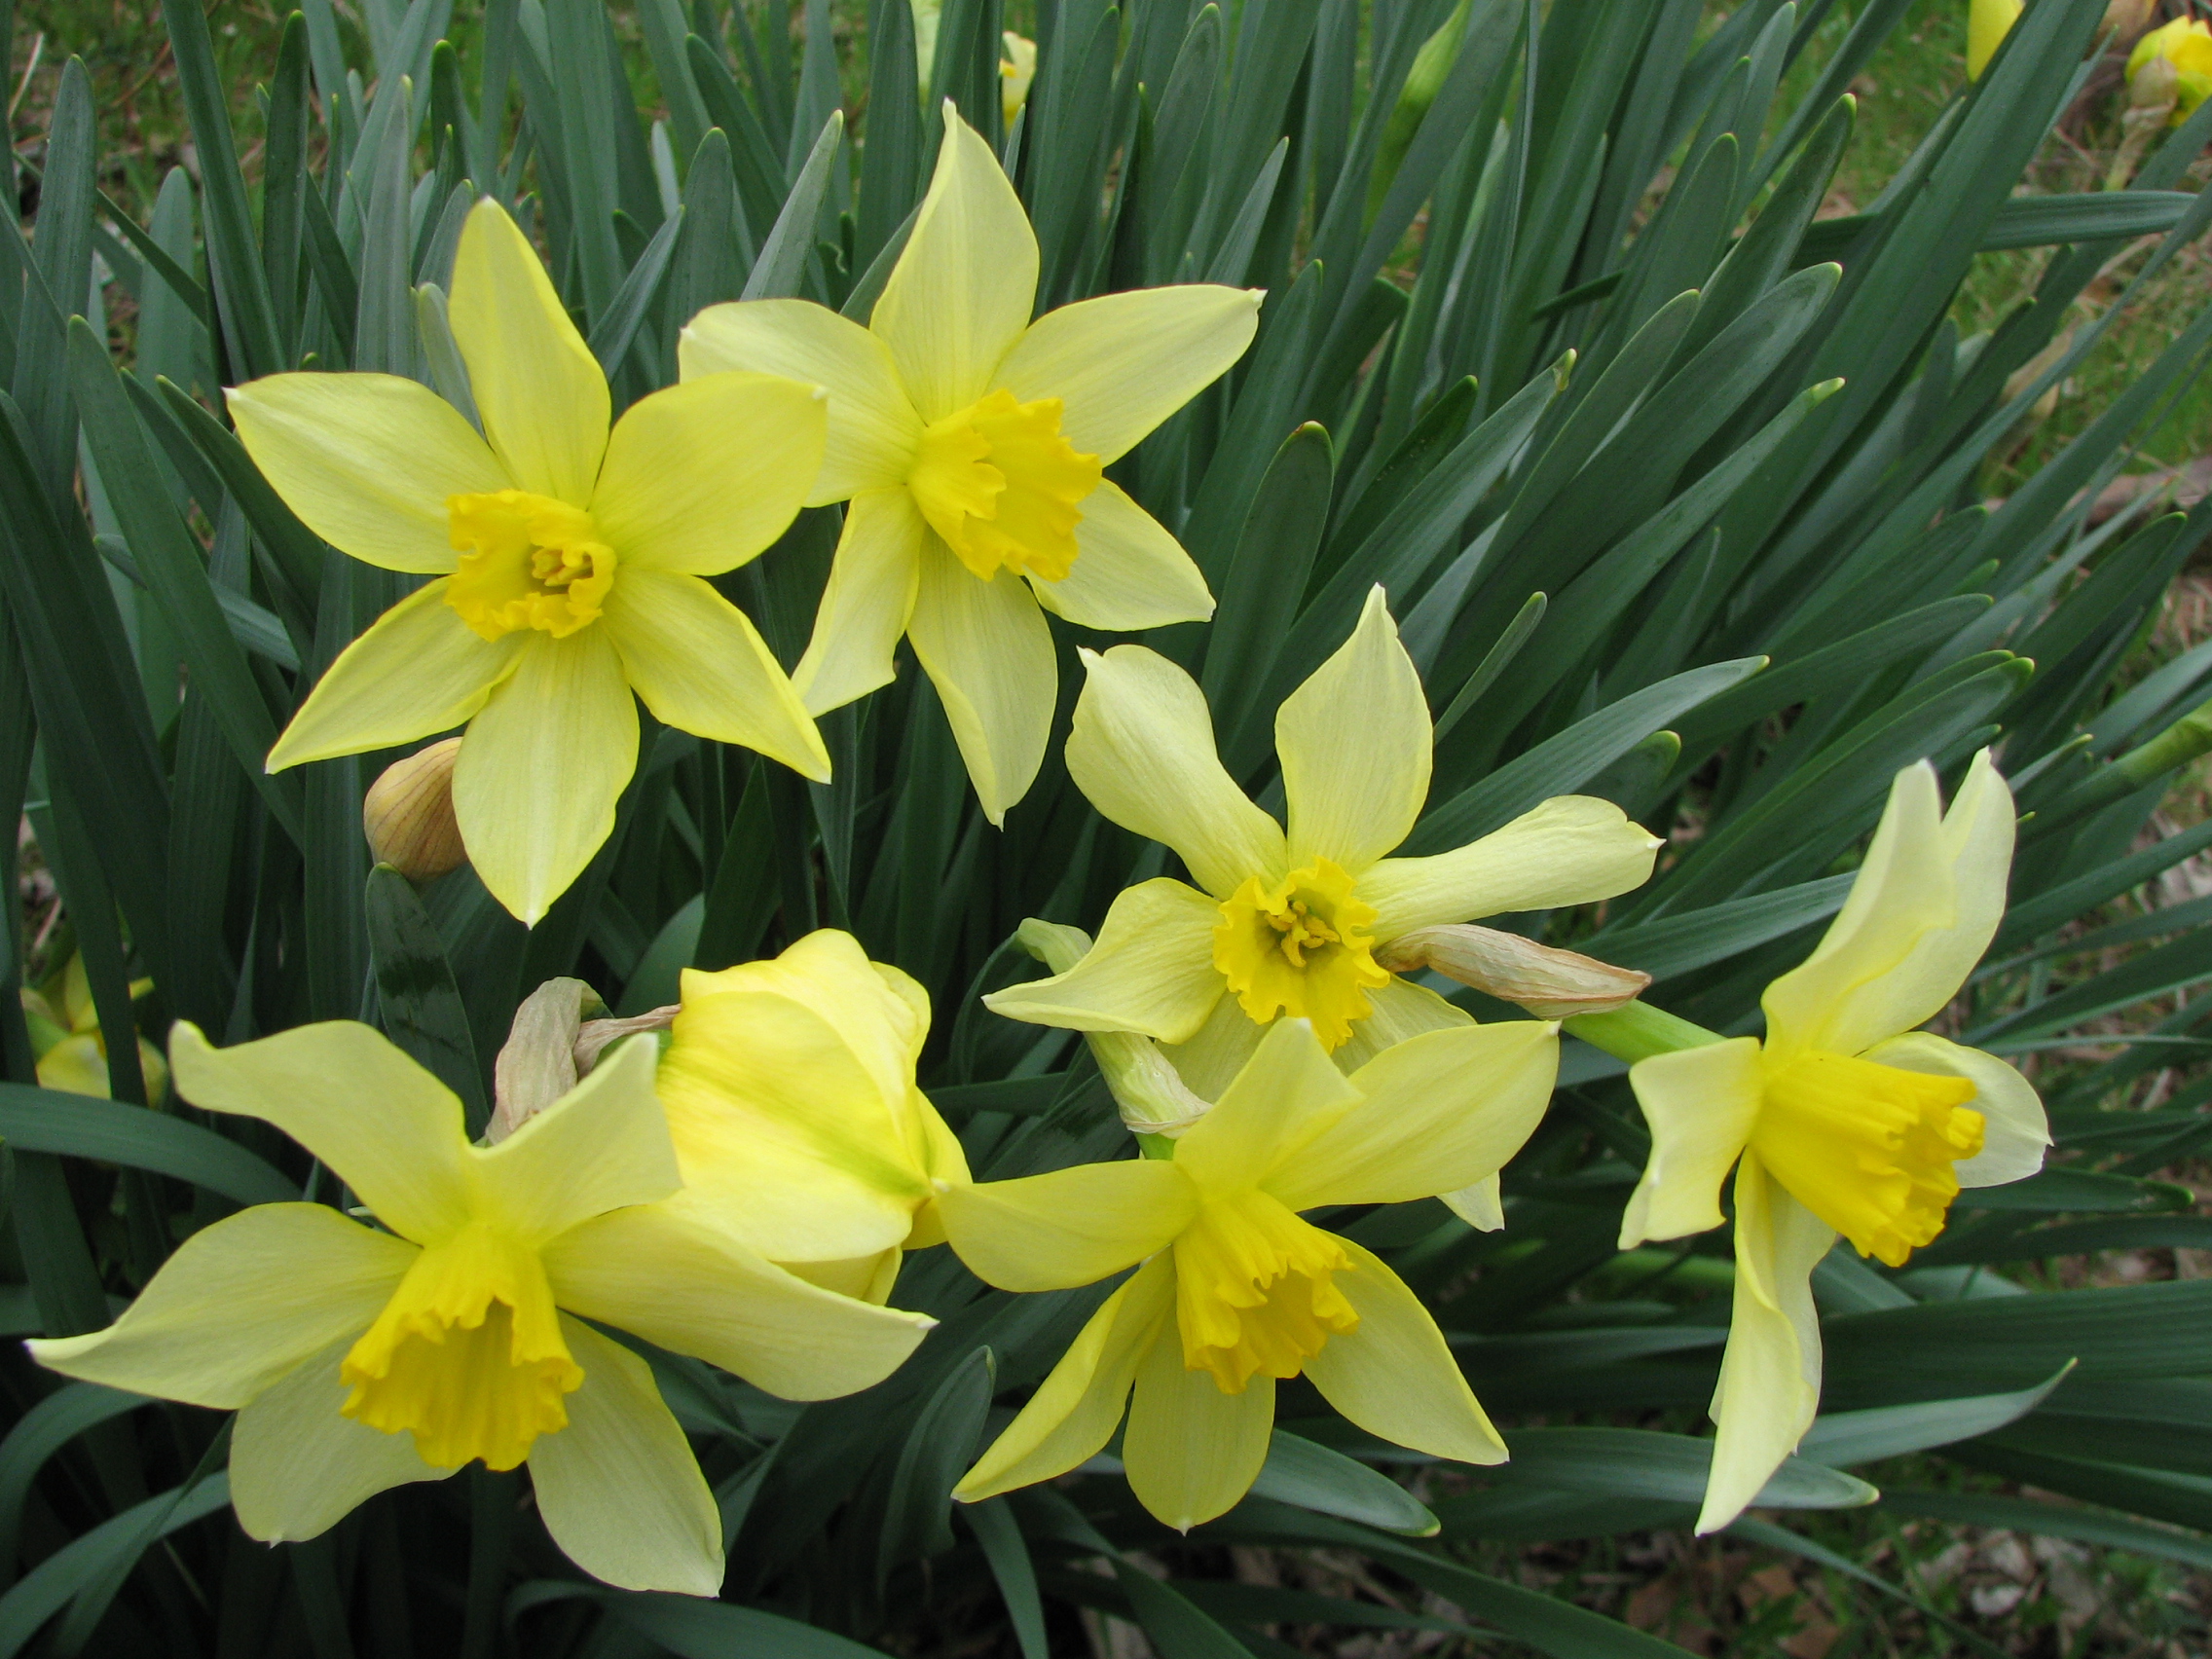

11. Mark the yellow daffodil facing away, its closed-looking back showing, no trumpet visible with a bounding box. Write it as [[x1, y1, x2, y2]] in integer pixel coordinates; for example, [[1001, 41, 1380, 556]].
[[659, 929, 969, 1301]]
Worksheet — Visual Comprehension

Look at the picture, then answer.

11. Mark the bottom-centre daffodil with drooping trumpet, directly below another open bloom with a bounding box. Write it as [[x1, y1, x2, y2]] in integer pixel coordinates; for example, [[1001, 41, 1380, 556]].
[[938, 1019, 1555, 1530]]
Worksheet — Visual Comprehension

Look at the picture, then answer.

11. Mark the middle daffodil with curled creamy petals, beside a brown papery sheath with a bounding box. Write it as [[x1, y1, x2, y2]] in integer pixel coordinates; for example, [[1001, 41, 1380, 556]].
[[984, 588, 1661, 1097]]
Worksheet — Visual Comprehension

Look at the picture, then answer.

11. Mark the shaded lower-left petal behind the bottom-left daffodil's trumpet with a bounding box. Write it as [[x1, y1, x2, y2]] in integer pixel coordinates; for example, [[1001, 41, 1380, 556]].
[[230, 1336, 454, 1544]]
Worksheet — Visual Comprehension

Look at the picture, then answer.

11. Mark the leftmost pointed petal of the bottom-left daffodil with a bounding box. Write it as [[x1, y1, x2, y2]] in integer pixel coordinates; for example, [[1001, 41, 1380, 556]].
[[29, 1203, 416, 1412]]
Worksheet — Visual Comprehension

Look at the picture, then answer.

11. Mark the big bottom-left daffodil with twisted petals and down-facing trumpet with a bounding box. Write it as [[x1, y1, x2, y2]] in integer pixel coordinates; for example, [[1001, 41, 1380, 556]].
[[31, 1022, 932, 1595]]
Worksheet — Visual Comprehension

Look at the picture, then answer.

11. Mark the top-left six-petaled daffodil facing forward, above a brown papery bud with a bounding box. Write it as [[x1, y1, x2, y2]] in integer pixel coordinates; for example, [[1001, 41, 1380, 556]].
[[230, 199, 830, 925]]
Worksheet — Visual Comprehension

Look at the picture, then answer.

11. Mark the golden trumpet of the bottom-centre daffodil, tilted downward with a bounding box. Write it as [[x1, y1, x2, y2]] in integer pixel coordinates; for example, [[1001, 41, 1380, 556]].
[[1174, 1190, 1360, 1393]]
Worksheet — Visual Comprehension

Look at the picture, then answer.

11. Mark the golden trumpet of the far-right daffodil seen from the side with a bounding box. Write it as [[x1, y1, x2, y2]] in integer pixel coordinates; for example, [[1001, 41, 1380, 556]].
[[1751, 1052, 1982, 1268]]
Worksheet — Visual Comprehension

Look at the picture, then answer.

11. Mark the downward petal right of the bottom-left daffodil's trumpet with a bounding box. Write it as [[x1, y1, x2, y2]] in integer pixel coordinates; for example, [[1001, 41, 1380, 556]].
[[531, 1318, 723, 1595]]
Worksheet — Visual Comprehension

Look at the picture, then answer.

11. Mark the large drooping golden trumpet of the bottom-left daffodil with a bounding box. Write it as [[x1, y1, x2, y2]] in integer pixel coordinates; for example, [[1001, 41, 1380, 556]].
[[339, 1228, 584, 1469]]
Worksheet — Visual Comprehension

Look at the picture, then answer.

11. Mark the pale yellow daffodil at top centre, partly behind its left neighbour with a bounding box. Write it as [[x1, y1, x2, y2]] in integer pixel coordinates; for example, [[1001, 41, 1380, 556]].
[[680, 104, 1261, 823]]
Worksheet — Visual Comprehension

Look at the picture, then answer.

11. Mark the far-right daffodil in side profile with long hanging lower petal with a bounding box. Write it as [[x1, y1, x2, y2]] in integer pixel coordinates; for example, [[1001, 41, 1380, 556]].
[[1621, 750, 2050, 1532]]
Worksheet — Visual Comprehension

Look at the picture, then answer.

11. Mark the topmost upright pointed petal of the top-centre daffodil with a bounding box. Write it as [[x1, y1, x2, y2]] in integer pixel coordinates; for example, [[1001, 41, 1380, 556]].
[[869, 102, 1038, 421]]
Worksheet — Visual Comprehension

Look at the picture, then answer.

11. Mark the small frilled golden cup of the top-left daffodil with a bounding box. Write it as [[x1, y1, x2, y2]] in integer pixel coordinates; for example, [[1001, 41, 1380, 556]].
[[445, 489, 615, 640]]
